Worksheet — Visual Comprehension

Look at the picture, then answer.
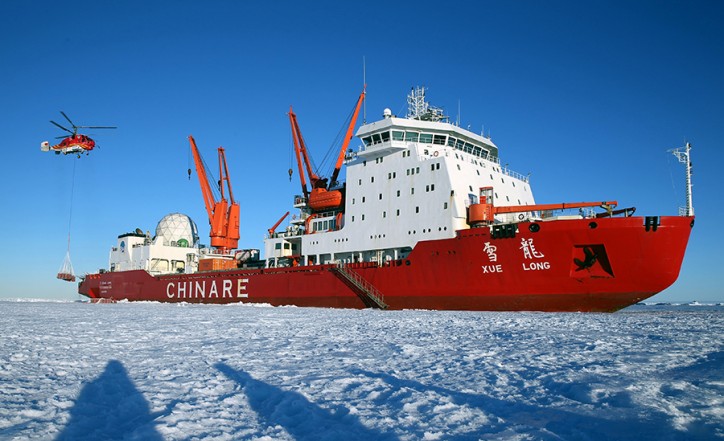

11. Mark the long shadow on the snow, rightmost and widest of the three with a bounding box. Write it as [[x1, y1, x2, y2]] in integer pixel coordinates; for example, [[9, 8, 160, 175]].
[[351, 369, 688, 441]]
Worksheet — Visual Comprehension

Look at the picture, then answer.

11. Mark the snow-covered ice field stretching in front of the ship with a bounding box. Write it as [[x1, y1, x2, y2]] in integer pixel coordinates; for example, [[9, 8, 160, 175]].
[[0, 301, 724, 440]]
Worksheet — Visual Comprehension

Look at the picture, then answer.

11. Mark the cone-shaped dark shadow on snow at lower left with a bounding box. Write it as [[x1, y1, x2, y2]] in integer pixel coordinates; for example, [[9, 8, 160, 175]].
[[56, 360, 162, 441]]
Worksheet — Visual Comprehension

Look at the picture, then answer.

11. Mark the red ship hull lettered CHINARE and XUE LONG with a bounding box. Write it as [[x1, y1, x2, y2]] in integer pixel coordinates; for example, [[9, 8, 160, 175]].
[[79, 216, 694, 312]]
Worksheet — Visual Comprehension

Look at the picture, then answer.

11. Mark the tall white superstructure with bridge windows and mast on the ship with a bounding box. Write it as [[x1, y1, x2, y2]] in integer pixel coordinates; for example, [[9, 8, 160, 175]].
[[265, 88, 535, 266]]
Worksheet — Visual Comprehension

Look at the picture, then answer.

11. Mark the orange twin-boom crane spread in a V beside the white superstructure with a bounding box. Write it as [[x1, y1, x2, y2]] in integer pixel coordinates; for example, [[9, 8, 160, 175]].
[[289, 90, 365, 211]]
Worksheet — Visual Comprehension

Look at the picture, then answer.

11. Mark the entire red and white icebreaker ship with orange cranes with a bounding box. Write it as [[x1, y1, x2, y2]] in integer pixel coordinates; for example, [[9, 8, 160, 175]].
[[79, 88, 694, 311]]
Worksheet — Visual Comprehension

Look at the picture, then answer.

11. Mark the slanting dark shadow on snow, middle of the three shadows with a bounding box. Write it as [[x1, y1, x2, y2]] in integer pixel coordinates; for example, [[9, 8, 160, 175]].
[[214, 363, 397, 441]]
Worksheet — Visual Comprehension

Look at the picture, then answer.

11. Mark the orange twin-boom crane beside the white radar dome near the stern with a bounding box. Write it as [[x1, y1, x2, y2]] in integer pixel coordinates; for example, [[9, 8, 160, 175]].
[[189, 135, 239, 251]]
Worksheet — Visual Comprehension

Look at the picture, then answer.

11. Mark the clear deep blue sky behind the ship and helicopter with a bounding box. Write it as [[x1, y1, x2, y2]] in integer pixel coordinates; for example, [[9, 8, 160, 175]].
[[0, 0, 724, 301]]
